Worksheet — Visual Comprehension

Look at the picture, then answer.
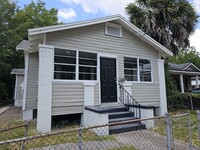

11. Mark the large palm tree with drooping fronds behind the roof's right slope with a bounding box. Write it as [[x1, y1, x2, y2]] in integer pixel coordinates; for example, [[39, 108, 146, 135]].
[[126, 0, 198, 54]]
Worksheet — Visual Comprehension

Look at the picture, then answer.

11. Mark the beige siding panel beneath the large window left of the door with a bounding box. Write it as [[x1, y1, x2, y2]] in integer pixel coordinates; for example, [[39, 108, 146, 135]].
[[52, 81, 84, 116]]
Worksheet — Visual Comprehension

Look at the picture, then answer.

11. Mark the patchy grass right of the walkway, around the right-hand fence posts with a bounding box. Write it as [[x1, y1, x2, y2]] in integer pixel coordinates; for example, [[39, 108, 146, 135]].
[[155, 109, 200, 146]]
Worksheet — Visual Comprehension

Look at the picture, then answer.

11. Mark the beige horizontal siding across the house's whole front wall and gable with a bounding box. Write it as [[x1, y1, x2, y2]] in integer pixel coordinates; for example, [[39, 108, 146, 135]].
[[41, 23, 160, 115]]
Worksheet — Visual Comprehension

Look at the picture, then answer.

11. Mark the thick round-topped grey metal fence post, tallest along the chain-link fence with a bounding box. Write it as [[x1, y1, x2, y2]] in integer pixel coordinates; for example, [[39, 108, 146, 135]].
[[165, 113, 172, 150]]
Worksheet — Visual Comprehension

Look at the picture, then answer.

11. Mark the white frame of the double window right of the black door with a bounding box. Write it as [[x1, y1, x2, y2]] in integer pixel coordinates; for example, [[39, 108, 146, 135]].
[[123, 56, 153, 83]]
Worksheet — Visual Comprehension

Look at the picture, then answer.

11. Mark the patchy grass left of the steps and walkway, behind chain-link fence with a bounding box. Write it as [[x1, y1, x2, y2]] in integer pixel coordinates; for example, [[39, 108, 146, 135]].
[[0, 119, 116, 149]]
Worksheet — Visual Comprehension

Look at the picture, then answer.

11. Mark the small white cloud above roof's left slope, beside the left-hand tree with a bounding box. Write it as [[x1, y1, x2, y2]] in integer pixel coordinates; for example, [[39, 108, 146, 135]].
[[58, 8, 76, 19]]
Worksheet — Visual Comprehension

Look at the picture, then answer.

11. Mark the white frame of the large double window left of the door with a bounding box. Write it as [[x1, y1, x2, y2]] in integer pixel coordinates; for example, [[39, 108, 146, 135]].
[[53, 47, 99, 83]]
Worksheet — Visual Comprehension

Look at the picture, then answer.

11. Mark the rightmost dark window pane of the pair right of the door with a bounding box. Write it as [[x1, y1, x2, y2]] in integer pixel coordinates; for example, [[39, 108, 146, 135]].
[[139, 59, 151, 82]]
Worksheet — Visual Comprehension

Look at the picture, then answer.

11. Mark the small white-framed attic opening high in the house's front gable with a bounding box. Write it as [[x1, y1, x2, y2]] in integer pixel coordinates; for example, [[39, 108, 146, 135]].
[[105, 23, 122, 37]]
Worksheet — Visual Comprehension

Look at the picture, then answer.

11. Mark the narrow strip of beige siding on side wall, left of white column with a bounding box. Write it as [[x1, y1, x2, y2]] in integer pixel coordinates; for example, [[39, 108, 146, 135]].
[[26, 52, 39, 109]]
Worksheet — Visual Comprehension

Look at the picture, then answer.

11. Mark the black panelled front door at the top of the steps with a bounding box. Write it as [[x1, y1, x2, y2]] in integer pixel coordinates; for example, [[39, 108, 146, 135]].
[[100, 57, 117, 103]]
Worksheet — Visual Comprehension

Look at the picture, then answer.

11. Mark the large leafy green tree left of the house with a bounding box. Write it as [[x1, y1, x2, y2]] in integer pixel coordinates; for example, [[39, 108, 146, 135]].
[[0, 0, 58, 103]]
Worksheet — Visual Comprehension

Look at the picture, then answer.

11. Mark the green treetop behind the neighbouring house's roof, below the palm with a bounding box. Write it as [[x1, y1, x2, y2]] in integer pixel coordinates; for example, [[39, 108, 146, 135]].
[[169, 47, 200, 68]]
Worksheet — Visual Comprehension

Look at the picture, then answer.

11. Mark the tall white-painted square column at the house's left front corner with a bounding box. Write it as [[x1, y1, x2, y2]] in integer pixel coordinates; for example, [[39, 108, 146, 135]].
[[37, 44, 54, 132]]
